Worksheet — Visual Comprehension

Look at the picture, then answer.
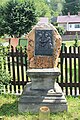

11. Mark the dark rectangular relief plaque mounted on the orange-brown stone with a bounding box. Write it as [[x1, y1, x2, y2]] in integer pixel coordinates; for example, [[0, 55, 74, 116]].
[[35, 30, 53, 56]]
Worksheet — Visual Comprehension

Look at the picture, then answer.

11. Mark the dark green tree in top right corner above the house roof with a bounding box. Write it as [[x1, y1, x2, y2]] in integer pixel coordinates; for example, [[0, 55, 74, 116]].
[[62, 0, 80, 15]]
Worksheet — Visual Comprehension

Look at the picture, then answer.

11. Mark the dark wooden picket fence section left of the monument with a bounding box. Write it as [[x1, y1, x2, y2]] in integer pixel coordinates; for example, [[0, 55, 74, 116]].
[[0, 46, 28, 93]]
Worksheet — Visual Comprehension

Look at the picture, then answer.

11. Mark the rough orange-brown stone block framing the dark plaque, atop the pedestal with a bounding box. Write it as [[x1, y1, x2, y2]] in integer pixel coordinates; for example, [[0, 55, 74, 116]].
[[27, 18, 62, 68]]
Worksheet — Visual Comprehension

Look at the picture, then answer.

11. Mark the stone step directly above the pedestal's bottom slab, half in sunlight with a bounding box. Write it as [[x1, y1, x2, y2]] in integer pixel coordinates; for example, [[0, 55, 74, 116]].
[[19, 96, 66, 103]]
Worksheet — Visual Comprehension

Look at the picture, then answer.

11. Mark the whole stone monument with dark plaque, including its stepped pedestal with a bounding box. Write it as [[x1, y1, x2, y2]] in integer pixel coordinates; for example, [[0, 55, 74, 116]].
[[18, 18, 67, 112]]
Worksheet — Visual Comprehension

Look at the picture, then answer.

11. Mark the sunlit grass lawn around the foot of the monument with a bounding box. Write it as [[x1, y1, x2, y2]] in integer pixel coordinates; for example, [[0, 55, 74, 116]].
[[0, 95, 80, 120]]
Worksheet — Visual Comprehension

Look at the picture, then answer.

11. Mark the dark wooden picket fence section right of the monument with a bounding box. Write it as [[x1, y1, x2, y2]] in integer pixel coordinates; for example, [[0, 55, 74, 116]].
[[57, 46, 80, 96]]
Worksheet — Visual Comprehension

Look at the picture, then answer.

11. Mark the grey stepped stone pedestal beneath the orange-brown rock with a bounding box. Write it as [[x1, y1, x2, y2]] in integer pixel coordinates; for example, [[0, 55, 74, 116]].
[[18, 68, 67, 112]]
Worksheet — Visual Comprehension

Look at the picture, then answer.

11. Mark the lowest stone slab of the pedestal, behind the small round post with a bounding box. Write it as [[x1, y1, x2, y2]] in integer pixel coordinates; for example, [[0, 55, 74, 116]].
[[18, 102, 67, 113]]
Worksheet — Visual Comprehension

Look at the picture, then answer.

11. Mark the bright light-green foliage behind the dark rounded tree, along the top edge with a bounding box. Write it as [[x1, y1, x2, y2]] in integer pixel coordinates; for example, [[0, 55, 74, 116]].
[[0, 0, 65, 17]]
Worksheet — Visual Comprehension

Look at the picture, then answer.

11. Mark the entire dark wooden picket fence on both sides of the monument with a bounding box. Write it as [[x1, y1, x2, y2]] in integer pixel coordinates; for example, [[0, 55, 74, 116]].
[[0, 46, 80, 96]]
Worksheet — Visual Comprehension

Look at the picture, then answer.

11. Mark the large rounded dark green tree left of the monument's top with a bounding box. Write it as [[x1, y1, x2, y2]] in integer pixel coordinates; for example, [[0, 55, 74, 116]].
[[0, 0, 36, 37]]
